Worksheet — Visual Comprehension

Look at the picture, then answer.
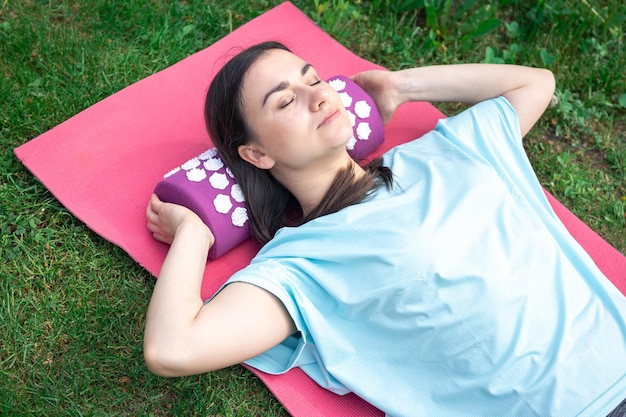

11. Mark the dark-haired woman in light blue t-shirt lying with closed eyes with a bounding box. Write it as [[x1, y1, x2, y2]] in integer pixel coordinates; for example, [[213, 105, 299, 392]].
[[144, 42, 626, 416]]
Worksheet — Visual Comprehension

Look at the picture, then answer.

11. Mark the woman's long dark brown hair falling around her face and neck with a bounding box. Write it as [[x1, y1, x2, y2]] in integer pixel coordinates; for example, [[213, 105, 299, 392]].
[[204, 42, 392, 244]]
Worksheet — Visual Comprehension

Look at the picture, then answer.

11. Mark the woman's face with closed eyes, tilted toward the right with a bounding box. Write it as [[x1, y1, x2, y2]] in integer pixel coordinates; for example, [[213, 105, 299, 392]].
[[242, 49, 352, 169]]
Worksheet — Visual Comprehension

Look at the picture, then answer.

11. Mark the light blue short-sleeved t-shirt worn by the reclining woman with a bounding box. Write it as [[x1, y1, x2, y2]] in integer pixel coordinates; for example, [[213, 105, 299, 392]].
[[222, 98, 626, 417]]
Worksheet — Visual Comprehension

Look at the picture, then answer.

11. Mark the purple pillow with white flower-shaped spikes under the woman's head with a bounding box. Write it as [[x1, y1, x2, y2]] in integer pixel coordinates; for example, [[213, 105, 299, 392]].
[[154, 75, 384, 259]]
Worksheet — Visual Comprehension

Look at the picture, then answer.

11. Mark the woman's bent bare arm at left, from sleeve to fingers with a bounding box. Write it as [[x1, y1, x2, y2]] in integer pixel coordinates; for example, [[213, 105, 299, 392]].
[[144, 196, 295, 376]]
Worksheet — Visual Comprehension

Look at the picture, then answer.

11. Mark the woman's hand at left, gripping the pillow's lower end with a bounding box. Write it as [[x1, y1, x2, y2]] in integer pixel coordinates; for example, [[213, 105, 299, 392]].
[[146, 194, 215, 247]]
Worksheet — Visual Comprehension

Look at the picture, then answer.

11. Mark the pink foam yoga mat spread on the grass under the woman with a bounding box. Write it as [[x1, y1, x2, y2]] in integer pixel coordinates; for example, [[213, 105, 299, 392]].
[[15, 3, 626, 417]]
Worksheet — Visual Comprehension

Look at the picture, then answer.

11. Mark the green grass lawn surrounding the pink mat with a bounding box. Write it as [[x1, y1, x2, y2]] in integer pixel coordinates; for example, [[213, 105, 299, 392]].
[[0, 0, 626, 416]]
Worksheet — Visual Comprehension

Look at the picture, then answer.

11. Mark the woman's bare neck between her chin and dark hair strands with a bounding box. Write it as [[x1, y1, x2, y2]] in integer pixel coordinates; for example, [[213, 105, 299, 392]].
[[272, 153, 365, 217]]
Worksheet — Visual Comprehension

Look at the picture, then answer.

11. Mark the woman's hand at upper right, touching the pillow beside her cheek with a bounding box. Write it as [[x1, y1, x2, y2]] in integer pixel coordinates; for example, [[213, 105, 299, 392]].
[[352, 70, 402, 124]]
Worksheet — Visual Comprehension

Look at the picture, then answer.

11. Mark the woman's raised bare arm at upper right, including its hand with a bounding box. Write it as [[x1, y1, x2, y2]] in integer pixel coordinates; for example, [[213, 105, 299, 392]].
[[353, 64, 555, 136]]
